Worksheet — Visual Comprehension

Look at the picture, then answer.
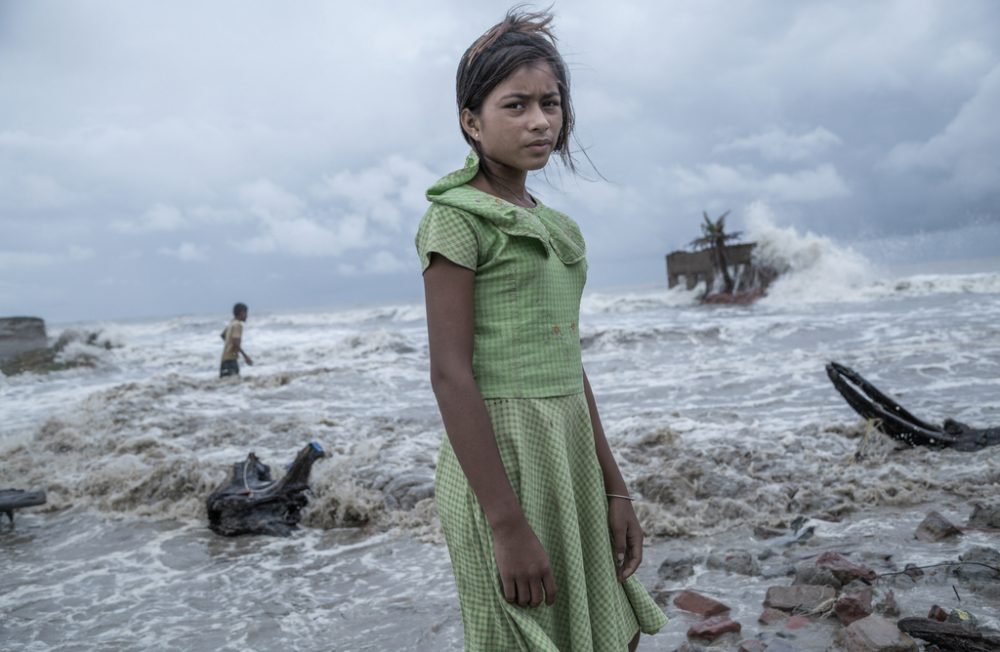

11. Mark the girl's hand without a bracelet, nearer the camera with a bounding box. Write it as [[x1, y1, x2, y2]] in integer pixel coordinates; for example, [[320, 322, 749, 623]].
[[493, 519, 556, 607]]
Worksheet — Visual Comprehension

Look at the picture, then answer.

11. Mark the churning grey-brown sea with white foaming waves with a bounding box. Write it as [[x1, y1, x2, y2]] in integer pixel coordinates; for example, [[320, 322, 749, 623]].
[[0, 223, 1000, 652]]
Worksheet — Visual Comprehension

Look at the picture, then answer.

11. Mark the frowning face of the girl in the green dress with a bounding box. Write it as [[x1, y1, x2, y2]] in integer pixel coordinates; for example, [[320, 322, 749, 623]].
[[462, 61, 563, 174]]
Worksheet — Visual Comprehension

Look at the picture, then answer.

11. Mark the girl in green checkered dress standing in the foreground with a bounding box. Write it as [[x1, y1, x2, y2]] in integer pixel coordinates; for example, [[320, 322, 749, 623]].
[[416, 9, 666, 652]]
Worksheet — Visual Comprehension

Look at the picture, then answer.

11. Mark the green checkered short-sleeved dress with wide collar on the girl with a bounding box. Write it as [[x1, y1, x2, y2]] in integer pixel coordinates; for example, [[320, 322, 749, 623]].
[[416, 153, 666, 652]]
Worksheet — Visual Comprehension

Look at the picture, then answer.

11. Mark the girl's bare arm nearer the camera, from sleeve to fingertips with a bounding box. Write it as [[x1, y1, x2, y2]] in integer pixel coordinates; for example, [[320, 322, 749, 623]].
[[424, 254, 556, 606]]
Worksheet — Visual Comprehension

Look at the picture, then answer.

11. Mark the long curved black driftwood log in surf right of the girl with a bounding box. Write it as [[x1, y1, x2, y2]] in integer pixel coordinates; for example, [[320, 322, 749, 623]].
[[826, 362, 1000, 451]]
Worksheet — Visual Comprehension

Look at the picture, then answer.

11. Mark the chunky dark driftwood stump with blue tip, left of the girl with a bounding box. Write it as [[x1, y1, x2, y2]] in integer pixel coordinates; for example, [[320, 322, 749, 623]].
[[206, 442, 326, 536]]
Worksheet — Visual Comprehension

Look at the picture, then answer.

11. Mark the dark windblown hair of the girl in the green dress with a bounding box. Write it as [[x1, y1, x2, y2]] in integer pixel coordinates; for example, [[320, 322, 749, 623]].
[[455, 5, 576, 170]]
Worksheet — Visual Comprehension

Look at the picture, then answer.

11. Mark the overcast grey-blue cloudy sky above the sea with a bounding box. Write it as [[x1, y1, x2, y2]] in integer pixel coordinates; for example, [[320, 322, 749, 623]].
[[0, 0, 1000, 321]]
